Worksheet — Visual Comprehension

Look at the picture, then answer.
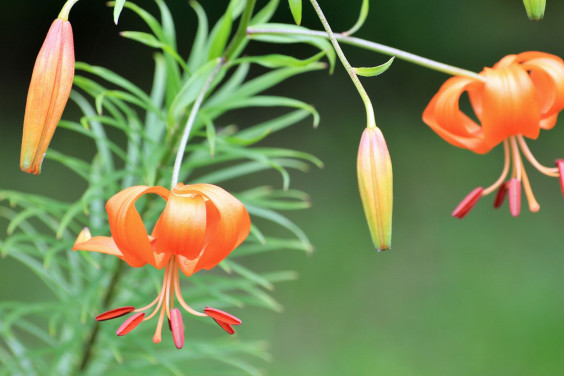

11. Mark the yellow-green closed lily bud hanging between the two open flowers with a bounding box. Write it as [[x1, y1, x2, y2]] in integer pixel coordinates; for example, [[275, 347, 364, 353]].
[[357, 127, 393, 251]]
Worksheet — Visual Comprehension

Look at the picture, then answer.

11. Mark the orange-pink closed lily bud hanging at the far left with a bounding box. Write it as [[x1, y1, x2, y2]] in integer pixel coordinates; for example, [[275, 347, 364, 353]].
[[20, 13, 74, 175]]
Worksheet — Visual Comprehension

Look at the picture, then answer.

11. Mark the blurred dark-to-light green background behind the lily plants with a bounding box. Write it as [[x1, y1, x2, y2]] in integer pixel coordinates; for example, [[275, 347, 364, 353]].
[[0, 0, 564, 376]]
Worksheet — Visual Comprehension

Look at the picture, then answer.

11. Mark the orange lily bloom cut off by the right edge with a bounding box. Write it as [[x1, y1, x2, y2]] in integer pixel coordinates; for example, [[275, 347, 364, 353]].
[[423, 52, 564, 218]]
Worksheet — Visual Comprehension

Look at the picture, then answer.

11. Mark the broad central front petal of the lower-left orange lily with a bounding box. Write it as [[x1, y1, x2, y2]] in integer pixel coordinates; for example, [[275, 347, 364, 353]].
[[153, 189, 206, 259]]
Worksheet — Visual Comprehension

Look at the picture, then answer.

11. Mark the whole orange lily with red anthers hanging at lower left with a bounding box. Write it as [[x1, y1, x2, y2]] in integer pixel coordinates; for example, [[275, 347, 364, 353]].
[[73, 184, 251, 349]]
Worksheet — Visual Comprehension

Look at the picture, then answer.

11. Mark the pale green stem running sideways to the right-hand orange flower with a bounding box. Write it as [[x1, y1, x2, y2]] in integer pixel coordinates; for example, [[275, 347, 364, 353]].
[[247, 27, 484, 81]]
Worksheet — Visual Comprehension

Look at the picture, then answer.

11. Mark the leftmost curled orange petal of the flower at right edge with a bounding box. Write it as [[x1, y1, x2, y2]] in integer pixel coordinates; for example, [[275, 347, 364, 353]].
[[423, 77, 491, 153]]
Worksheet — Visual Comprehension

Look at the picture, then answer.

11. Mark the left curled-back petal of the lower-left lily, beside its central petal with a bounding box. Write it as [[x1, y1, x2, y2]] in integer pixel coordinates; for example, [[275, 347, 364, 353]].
[[106, 185, 170, 267]]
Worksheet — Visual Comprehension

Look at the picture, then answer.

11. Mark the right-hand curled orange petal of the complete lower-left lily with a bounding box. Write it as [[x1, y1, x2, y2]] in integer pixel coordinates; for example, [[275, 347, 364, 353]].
[[174, 184, 251, 271]]
